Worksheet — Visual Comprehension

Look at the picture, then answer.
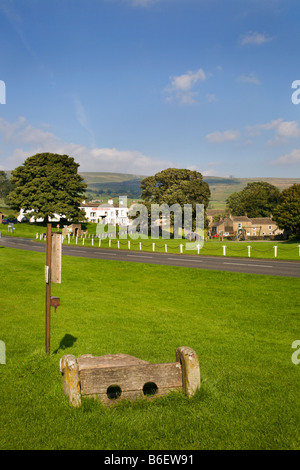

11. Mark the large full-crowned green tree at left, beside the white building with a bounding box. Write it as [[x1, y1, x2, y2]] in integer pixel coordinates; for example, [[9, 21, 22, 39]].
[[8, 153, 87, 222]]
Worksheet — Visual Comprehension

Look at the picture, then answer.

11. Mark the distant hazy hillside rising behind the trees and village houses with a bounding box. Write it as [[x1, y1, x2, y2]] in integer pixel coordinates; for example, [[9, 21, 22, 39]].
[[81, 172, 300, 209]]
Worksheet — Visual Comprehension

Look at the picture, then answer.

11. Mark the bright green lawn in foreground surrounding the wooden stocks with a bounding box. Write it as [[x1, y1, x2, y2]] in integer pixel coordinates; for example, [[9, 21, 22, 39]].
[[0, 248, 300, 450]]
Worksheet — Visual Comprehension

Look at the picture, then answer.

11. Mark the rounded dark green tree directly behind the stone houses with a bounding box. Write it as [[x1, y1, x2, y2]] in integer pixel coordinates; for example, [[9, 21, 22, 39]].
[[226, 181, 280, 217]]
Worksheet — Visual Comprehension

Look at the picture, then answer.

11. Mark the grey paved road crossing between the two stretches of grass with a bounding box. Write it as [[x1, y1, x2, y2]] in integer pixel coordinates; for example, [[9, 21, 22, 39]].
[[0, 237, 300, 277]]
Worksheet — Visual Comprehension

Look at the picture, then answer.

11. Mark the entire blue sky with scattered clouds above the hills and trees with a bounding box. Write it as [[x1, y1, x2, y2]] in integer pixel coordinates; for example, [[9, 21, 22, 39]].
[[0, 0, 300, 177]]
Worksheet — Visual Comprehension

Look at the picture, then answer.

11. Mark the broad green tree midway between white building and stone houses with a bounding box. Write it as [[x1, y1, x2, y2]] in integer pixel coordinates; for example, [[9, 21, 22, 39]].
[[140, 168, 210, 232]]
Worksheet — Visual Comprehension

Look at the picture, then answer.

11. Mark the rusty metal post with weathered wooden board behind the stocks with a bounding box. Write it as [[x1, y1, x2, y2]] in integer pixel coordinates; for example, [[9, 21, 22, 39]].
[[45, 224, 62, 354]]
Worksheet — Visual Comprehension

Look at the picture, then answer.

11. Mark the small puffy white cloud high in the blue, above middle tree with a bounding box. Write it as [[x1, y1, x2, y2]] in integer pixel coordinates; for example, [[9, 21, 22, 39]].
[[165, 69, 207, 104]]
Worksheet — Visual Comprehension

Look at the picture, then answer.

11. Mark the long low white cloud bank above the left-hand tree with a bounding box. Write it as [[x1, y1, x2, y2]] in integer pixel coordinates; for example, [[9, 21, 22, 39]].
[[0, 118, 174, 174]]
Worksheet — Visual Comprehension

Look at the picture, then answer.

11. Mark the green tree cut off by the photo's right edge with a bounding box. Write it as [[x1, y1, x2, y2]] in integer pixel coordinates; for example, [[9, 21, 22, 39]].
[[273, 184, 300, 236]]
